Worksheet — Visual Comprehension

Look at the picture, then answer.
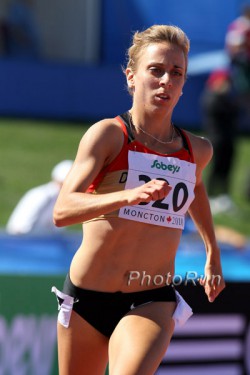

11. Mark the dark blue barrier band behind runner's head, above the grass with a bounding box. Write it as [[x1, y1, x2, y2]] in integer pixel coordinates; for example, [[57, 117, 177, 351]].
[[0, 59, 207, 127]]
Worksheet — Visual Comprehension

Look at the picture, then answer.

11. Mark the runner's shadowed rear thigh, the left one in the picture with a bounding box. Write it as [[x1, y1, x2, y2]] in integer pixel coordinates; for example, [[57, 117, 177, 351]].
[[57, 311, 108, 375]]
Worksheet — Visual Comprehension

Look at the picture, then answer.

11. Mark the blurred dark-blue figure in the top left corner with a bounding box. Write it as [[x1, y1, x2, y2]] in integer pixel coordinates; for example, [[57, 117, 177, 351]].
[[7, 0, 40, 59]]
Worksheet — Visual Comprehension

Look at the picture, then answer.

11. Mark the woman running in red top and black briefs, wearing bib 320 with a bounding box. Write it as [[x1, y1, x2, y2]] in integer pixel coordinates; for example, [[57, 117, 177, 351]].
[[53, 25, 225, 375]]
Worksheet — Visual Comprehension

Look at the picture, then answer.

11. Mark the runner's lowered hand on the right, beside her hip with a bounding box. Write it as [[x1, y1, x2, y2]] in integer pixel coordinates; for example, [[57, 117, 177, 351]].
[[199, 260, 226, 302]]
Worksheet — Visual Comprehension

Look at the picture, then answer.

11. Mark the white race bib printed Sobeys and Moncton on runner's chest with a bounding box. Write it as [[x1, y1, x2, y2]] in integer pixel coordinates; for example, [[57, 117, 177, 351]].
[[119, 151, 196, 229]]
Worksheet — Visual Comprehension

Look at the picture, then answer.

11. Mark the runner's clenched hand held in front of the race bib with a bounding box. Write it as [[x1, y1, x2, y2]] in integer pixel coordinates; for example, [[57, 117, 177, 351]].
[[127, 180, 172, 205]]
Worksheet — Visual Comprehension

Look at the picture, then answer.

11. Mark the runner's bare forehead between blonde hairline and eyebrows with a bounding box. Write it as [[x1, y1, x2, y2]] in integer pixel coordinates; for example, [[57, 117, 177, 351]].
[[138, 42, 186, 69]]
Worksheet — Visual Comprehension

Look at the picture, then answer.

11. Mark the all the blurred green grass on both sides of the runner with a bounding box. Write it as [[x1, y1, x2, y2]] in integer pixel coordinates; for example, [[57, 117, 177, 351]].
[[0, 119, 250, 237]]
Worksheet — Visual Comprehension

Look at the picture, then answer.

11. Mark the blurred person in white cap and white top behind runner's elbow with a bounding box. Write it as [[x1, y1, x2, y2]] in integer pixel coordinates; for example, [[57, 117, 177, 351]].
[[6, 160, 73, 235]]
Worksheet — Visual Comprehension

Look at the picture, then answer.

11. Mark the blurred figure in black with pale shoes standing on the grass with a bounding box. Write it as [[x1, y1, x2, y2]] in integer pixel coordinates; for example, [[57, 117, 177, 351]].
[[201, 70, 238, 213]]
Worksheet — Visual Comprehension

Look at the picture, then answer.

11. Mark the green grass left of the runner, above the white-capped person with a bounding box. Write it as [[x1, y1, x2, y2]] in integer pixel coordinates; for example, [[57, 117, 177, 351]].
[[0, 119, 87, 227]]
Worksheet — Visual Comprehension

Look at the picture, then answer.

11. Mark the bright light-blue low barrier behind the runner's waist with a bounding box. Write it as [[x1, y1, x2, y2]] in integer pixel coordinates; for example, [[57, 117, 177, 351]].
[[0, 232, 250, 282]]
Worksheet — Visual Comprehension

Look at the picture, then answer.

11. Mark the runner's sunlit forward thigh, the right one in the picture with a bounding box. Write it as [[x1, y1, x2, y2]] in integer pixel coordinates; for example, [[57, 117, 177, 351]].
[[109, 302, 176, 375]]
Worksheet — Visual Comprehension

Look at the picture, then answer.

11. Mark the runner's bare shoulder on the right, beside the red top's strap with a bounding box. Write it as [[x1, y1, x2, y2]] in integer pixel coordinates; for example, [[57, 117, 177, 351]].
[[186, 131, 213, 169]]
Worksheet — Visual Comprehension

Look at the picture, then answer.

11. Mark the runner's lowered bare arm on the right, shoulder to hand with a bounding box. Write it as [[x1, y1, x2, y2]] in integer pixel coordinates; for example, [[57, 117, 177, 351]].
[[189, 136, 225, 302]]
